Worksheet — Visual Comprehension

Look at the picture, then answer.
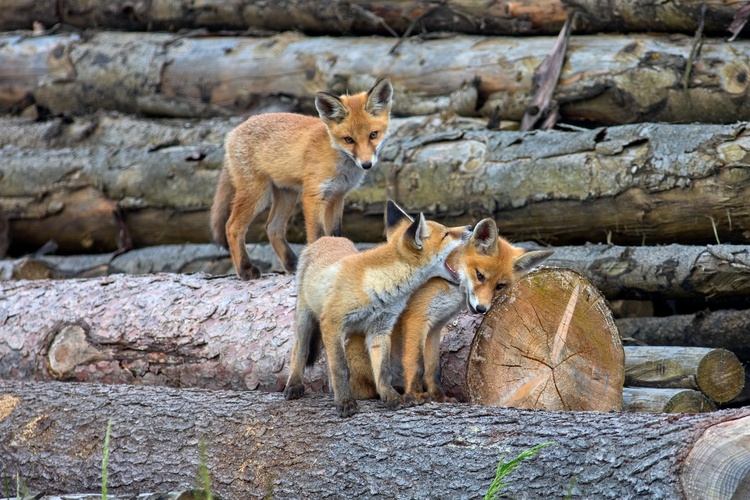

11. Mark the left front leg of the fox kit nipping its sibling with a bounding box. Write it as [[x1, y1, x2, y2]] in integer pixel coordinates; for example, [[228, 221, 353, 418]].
[[320, 318, 358, 417]]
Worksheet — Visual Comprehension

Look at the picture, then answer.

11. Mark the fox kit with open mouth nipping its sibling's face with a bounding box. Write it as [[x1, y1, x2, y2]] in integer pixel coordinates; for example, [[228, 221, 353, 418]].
[[284, 201, 469, 417]]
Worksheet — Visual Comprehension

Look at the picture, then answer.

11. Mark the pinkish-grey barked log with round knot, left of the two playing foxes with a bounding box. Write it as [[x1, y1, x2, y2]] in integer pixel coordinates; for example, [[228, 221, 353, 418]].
[[0, 275, 328, 391]]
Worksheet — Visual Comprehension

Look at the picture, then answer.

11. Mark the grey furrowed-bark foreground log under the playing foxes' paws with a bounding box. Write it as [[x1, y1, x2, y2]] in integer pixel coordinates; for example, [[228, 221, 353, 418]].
[[0, 381, 750, 499]]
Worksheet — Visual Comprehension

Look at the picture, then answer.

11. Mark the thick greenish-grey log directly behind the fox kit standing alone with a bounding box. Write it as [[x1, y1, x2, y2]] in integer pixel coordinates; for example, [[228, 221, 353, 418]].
[[0, 114, 750, 257]]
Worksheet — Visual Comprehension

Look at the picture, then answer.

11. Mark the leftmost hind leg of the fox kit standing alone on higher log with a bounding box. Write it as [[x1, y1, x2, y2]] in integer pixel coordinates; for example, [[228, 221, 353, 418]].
[[226, 179, 270, 280]]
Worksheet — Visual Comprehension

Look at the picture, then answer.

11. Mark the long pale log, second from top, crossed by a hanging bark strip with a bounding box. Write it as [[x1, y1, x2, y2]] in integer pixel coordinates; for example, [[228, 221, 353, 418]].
[[7, 32, 750, 124]]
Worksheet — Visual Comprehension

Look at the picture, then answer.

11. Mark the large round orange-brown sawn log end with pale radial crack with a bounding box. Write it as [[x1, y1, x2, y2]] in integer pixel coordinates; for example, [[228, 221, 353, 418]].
[[466, 269, 625, 411]]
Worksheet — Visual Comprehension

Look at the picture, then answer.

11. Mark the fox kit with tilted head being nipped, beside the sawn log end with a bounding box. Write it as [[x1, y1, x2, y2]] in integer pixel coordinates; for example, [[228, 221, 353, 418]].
[[346, 219, 553, 405]]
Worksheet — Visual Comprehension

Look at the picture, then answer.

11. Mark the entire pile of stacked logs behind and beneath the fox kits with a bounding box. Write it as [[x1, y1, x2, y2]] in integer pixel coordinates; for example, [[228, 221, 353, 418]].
[[0, 0, 750, 498]]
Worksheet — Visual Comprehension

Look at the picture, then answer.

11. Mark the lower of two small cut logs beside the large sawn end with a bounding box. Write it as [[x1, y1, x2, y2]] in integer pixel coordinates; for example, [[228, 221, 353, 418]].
[[622, 387, 716, 413]]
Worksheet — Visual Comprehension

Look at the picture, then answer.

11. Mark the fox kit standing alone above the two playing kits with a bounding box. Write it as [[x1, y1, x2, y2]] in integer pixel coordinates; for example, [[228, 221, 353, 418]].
[[211, 79, 393, 280]]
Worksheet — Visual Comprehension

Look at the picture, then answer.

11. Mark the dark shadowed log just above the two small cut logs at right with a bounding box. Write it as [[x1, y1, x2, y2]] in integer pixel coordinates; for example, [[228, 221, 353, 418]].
[[617, 310, 750, 363]]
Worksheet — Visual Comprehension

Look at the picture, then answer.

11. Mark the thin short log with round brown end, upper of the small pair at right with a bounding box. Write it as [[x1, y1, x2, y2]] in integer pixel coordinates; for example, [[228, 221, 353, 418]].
[[625, 346, 745, 403]]
